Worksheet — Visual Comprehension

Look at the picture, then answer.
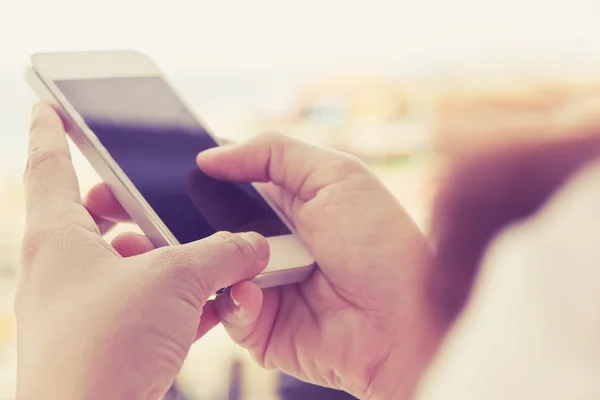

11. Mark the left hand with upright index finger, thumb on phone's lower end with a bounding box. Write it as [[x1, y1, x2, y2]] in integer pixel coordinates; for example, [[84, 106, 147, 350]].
[[15, 104, 269, 400]]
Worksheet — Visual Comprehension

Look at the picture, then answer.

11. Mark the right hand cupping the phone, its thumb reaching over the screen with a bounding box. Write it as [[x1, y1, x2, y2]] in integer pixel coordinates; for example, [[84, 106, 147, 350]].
[[197, 135, 440, 399]]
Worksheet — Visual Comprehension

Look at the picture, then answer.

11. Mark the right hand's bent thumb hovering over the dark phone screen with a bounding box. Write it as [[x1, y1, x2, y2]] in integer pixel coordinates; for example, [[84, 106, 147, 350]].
[[197, 134, 365, 200]]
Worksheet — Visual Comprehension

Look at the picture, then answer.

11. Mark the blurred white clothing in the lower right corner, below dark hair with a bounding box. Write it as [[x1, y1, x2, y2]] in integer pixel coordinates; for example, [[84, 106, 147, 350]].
[[415, 160, 600, 400]]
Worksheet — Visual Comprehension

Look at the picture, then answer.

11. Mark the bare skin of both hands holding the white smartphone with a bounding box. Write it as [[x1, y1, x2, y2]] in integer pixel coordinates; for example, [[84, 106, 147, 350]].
[[16, 104, 439, 399]]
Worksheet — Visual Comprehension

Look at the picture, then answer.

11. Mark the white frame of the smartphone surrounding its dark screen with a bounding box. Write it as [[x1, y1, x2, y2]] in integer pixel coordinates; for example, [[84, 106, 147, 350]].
[[28, 50, 314, 287]]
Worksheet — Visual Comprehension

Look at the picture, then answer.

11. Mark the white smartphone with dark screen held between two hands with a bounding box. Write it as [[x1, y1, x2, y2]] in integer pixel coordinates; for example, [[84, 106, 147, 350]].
[[25, 51, 315, 288]]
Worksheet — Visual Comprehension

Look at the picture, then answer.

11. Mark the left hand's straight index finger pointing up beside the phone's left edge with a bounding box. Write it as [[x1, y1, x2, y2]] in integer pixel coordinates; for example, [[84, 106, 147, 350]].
[[24, 103, 81, 219]]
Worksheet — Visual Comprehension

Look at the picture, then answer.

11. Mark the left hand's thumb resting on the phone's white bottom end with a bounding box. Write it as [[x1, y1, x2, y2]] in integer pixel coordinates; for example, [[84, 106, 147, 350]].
[[147, 232, 269, 309]]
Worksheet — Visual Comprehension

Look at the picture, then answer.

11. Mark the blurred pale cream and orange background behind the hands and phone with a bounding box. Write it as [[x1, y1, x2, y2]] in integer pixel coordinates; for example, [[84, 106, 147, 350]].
[[0, 0, 600, 400]]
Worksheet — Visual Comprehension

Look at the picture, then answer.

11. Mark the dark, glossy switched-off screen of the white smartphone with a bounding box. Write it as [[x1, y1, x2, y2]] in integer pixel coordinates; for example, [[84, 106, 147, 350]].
[[55, 76, 291, 243]]
